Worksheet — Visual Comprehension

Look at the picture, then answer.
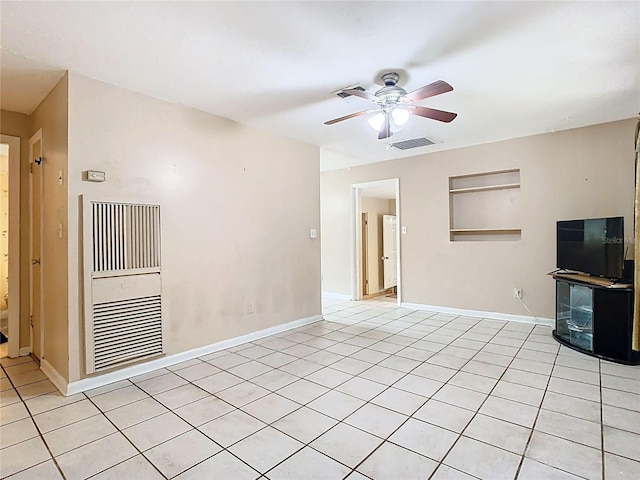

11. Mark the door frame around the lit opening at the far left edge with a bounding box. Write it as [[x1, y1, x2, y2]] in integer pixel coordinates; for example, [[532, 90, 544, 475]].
[[0, 134, 21, 358]]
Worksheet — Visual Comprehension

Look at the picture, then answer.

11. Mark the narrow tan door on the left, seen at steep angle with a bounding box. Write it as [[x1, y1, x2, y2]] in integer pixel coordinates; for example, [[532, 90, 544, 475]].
[[29, 130, 43, 362]]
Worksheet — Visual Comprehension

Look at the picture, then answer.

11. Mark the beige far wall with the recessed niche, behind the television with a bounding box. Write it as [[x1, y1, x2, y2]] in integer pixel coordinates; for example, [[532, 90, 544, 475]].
[[321, 120, 635, 318]]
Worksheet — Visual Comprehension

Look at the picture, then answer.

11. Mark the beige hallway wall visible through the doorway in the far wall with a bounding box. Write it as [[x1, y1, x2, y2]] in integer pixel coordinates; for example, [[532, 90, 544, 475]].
[[360, 196, 395, 294]]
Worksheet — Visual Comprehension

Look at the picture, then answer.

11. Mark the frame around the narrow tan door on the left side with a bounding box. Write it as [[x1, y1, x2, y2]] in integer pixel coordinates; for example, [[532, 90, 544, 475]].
[[29, 129, 45, 362]]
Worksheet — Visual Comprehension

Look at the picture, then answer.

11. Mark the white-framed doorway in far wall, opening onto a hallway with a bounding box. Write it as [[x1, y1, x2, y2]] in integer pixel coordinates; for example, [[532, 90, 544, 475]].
[[351, 178, 402, 306]]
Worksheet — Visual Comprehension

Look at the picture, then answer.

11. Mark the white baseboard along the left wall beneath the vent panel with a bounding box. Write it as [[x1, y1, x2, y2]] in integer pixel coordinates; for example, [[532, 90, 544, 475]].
[[67, 315, 322, 395]]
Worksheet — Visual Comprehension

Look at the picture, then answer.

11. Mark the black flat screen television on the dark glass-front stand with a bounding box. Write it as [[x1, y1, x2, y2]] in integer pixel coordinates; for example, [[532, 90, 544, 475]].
[[556, 217, 625, 279]]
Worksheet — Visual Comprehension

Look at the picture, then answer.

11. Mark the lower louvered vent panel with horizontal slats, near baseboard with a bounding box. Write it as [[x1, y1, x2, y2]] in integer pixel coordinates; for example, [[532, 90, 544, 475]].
[[93, 295, 162, 371]]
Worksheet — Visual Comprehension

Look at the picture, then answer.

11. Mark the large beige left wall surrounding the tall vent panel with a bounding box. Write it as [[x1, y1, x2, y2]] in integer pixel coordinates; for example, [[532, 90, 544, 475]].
[[68, 73, 321, 381]]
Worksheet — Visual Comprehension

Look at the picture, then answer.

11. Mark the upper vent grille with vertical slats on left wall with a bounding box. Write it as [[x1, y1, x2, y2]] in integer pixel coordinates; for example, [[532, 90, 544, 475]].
[[92, 202, 160, 272]]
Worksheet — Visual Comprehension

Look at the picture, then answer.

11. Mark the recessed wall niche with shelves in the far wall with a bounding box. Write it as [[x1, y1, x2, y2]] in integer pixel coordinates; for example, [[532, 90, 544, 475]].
[[449, 169, 522, 242]]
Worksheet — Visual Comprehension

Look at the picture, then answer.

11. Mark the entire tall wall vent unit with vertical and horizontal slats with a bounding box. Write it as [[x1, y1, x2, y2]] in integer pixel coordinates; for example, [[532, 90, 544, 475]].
[[83, 197, 163, 373]]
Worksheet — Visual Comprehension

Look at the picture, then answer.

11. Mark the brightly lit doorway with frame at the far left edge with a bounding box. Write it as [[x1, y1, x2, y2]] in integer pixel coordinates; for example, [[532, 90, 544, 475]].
[[0, 135, 20, 357]]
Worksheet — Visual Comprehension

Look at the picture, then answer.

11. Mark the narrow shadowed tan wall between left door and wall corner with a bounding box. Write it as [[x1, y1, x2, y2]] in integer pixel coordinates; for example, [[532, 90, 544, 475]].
[[27, 75, 69, 378]]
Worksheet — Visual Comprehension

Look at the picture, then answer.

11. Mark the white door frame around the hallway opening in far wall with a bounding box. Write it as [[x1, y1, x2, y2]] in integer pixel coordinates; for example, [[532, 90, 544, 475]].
[[350, 178, 402, 306]]
